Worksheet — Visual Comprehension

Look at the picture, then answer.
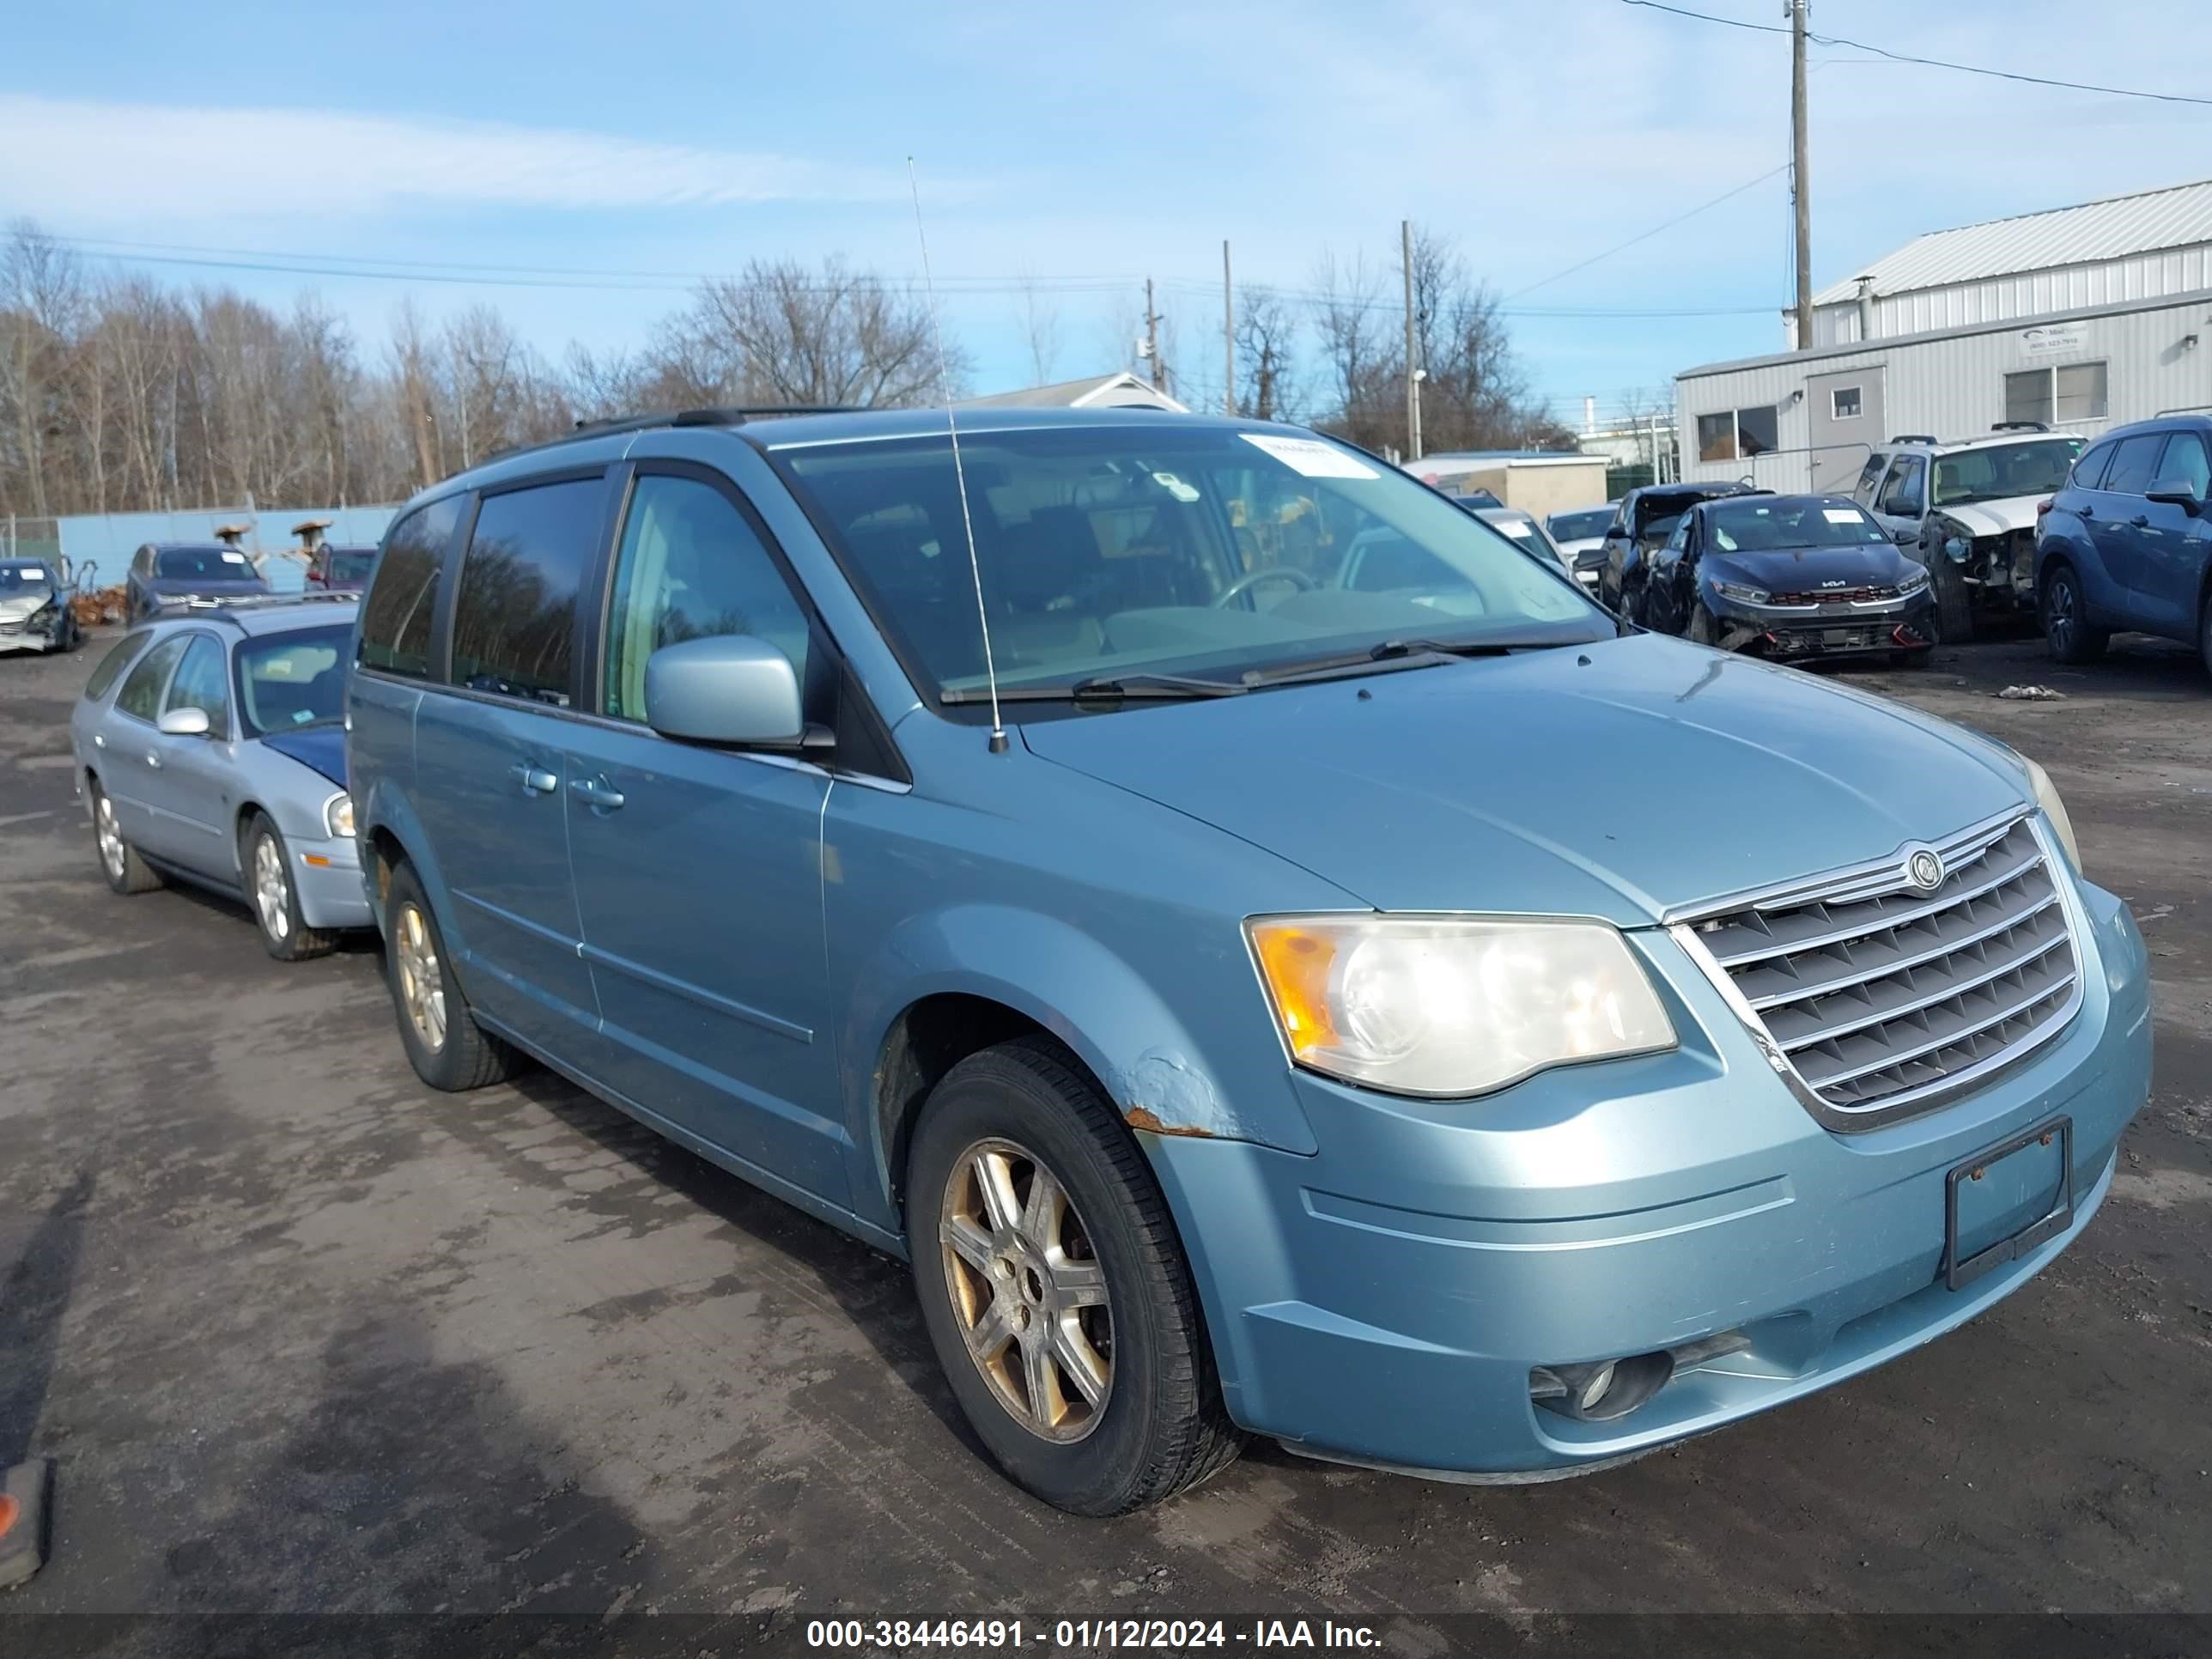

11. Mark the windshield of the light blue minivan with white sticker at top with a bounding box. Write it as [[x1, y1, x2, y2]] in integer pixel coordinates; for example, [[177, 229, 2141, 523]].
[[775, 418, 1614, 702]]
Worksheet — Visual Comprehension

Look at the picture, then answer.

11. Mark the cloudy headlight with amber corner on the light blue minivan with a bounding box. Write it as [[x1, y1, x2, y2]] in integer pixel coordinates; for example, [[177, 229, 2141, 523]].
[[1245, 915, 1674, 1095]]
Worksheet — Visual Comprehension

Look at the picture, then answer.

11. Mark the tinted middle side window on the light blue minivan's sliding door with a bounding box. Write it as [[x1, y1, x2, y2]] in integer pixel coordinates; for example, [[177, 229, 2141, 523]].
[[453, 477, 602, 706]]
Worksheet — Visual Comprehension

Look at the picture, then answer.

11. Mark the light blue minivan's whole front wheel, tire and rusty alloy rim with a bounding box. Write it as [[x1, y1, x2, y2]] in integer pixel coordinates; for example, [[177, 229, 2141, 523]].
[[907, 1037, 1243, 1516]]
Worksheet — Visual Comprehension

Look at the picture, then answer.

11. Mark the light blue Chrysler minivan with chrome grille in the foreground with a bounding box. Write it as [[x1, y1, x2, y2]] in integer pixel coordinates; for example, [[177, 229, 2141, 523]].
[[349, 410, 2150, 1516]]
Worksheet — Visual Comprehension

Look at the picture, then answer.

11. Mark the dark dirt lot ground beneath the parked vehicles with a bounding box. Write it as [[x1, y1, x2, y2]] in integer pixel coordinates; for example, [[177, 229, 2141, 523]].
[[0, 639, 2212, 1655]]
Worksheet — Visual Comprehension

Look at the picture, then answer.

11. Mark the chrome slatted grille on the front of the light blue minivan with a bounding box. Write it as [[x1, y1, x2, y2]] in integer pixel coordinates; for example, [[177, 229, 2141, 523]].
[[1694, 818, 2079, 1115]]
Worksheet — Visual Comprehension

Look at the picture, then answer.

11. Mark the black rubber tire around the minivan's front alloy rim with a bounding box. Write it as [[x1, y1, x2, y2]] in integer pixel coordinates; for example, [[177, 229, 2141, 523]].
[[907, 1037, 1243, 1516]]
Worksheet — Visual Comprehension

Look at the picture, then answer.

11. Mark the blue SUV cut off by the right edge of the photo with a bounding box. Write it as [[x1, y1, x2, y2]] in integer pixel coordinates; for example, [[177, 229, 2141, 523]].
[[2035, 414, 2212, 671]]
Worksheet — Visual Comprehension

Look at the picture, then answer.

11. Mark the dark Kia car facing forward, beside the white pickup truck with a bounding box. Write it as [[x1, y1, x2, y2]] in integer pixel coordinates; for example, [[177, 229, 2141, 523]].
[[1635, 495, 1936, 664]]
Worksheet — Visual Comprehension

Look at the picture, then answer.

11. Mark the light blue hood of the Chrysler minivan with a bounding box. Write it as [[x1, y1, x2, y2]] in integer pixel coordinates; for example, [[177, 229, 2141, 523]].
[[1022, 635, 2027, 927]]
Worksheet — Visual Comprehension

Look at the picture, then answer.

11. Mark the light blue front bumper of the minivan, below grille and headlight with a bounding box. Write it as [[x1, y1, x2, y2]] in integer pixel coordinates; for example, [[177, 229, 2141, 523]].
[[1146, 887, 2150, 1480]]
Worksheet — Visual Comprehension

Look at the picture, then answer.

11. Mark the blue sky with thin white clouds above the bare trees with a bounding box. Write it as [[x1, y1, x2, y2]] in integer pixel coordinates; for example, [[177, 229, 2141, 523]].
[[0, 0, 2212, 420]]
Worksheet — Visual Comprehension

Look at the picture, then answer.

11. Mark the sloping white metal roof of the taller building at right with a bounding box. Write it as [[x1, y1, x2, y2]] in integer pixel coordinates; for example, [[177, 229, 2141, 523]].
[[1814, 179, 2212, 309]]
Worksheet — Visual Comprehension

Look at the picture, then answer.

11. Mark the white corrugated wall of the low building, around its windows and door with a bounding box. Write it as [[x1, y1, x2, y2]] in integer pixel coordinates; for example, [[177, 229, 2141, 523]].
[[1674, 296, 2212, 489]]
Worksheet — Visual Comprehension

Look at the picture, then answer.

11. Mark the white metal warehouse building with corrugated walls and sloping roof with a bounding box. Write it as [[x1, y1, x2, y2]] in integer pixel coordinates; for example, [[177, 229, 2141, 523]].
[[1674, 179, 2212, 491]]
